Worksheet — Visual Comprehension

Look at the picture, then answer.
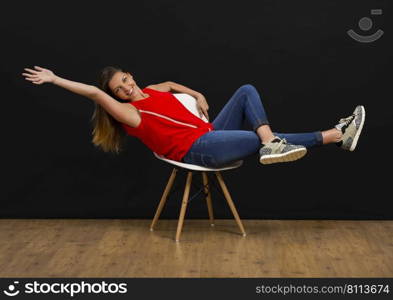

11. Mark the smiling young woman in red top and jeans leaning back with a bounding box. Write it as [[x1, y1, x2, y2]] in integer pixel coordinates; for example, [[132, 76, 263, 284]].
[[22, 66, 365, 167]]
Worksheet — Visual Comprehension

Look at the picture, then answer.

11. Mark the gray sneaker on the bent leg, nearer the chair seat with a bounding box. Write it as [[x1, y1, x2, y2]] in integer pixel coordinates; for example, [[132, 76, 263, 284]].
[[259, 137, 307, 165]]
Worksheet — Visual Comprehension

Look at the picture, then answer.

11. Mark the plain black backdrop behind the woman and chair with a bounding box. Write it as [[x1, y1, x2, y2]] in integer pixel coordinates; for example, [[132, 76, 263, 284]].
[[0, 0, 393, 219]]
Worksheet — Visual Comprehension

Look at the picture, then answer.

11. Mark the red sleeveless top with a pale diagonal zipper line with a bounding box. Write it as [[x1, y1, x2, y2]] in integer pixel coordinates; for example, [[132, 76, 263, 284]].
[[121, 88, 214, 161]]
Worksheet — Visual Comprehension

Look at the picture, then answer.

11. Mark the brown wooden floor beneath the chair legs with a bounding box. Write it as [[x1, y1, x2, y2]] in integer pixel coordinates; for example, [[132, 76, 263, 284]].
[[0, 219, 393, 277]]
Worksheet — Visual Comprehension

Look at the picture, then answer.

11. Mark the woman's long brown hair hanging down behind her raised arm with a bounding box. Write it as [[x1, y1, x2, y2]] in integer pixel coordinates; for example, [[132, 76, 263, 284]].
[[91, 66, 125, 154]]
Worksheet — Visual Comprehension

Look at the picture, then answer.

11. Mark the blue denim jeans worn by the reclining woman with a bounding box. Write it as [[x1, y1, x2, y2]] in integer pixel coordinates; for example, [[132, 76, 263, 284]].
[[182, 84, 322, 167]]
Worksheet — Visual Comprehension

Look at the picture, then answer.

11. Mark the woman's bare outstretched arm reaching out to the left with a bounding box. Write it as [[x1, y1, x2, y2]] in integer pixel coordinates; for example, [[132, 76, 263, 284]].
[[22, 66, 141, 127]]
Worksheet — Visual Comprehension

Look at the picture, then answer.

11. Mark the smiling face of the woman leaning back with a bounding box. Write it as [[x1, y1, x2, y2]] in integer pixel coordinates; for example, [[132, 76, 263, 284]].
[[108, 72, 139, 100]]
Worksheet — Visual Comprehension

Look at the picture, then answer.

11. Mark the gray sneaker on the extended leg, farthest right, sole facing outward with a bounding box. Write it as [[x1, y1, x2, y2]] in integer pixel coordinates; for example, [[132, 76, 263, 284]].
[[335, 105, 366, 151]]
